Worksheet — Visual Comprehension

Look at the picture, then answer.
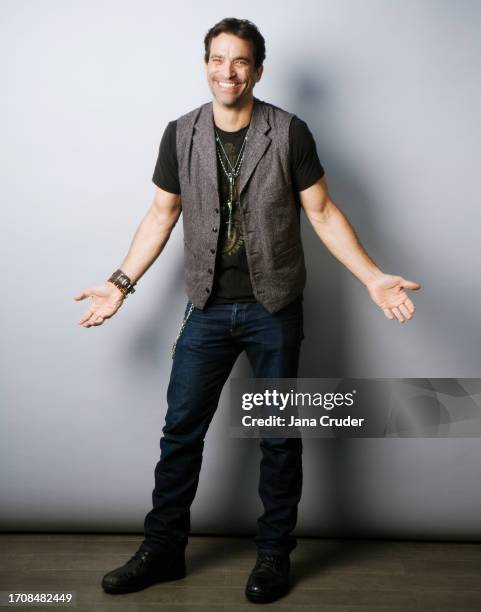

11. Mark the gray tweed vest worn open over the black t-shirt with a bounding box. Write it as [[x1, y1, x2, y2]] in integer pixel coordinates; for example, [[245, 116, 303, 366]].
[[176, 98, 306, 313]]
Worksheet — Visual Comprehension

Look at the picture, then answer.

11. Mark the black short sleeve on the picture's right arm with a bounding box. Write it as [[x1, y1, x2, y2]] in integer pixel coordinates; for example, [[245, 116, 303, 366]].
[[289, 115, 324, 191]]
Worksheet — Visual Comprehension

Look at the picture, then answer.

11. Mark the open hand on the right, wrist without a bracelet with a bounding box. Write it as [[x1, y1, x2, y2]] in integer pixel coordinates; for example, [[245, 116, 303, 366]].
[[366, 274, 421, 323]]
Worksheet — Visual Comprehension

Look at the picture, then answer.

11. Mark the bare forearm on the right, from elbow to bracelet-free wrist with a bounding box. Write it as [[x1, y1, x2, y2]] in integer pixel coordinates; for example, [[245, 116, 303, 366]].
[[311, 202, 382, 285]]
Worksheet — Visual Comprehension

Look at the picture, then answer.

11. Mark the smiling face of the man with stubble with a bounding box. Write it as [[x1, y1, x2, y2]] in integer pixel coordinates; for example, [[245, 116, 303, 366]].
[[205, 32, 262, 107]]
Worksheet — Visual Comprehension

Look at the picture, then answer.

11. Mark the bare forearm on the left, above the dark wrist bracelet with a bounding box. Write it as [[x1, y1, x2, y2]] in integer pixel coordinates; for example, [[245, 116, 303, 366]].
[[120, 210, 178, 282]]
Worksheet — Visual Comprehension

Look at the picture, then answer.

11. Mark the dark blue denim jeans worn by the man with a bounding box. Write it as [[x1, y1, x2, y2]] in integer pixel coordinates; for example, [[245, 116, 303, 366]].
[[143, 297, 304, 553]]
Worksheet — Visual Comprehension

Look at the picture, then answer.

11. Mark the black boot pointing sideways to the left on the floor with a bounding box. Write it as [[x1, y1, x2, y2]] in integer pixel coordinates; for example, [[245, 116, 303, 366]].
[[102, 547, 185, 594]]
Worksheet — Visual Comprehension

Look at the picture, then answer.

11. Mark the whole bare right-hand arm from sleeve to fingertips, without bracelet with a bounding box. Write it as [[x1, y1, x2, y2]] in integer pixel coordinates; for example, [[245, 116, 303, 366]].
[[299, 177, 421, 323]]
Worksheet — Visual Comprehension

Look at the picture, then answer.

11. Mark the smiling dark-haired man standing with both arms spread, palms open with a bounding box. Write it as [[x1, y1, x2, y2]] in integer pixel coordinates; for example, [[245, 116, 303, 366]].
[[75, 18, 420, 603]]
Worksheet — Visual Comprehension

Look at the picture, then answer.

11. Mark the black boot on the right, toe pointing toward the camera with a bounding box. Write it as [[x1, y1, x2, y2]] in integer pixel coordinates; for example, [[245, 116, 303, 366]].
[[246, 553, 290, 603]]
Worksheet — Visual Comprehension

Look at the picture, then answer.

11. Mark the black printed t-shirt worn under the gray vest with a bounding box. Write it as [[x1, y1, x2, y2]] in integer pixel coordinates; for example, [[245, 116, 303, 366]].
[[152, 116, 324, 304]]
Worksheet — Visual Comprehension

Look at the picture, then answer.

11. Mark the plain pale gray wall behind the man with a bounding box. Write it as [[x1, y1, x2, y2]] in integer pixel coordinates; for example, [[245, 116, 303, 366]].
[[0, 0, 481, 539]]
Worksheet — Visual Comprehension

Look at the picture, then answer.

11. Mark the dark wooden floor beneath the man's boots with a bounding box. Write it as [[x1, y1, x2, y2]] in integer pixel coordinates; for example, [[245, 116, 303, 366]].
[[0, 534, 481, 612]]
